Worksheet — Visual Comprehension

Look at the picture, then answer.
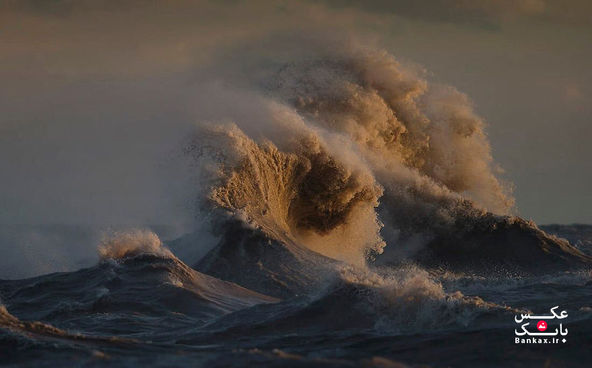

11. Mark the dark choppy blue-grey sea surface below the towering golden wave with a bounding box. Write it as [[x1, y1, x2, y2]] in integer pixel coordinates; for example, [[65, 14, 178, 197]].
[[0, 223, 592, 367]]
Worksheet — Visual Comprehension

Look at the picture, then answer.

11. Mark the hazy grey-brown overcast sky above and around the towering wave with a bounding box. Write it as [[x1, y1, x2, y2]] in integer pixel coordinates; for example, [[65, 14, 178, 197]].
[[0, 0, 592, 223]]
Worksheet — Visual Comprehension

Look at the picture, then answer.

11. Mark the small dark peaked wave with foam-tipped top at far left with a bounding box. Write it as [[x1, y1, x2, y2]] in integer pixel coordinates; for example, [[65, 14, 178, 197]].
[[0, 231, 277, 335]]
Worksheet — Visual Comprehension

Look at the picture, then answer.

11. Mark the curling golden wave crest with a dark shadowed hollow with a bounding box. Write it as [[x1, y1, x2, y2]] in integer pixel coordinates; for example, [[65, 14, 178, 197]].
[[190, 125, 385, 263]]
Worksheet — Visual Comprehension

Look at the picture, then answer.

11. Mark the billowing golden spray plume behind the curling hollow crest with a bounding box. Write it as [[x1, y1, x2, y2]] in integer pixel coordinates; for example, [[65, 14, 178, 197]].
[[268, 48, 513, 213]]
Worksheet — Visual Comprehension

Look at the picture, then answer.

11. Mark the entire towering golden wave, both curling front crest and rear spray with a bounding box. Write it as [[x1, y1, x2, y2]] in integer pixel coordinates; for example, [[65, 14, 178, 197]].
[[188, 43, 588, 274]]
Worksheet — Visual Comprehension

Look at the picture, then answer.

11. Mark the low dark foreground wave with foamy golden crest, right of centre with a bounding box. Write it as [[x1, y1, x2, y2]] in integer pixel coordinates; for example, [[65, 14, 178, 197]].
[[188, 265, 517, 344]]
